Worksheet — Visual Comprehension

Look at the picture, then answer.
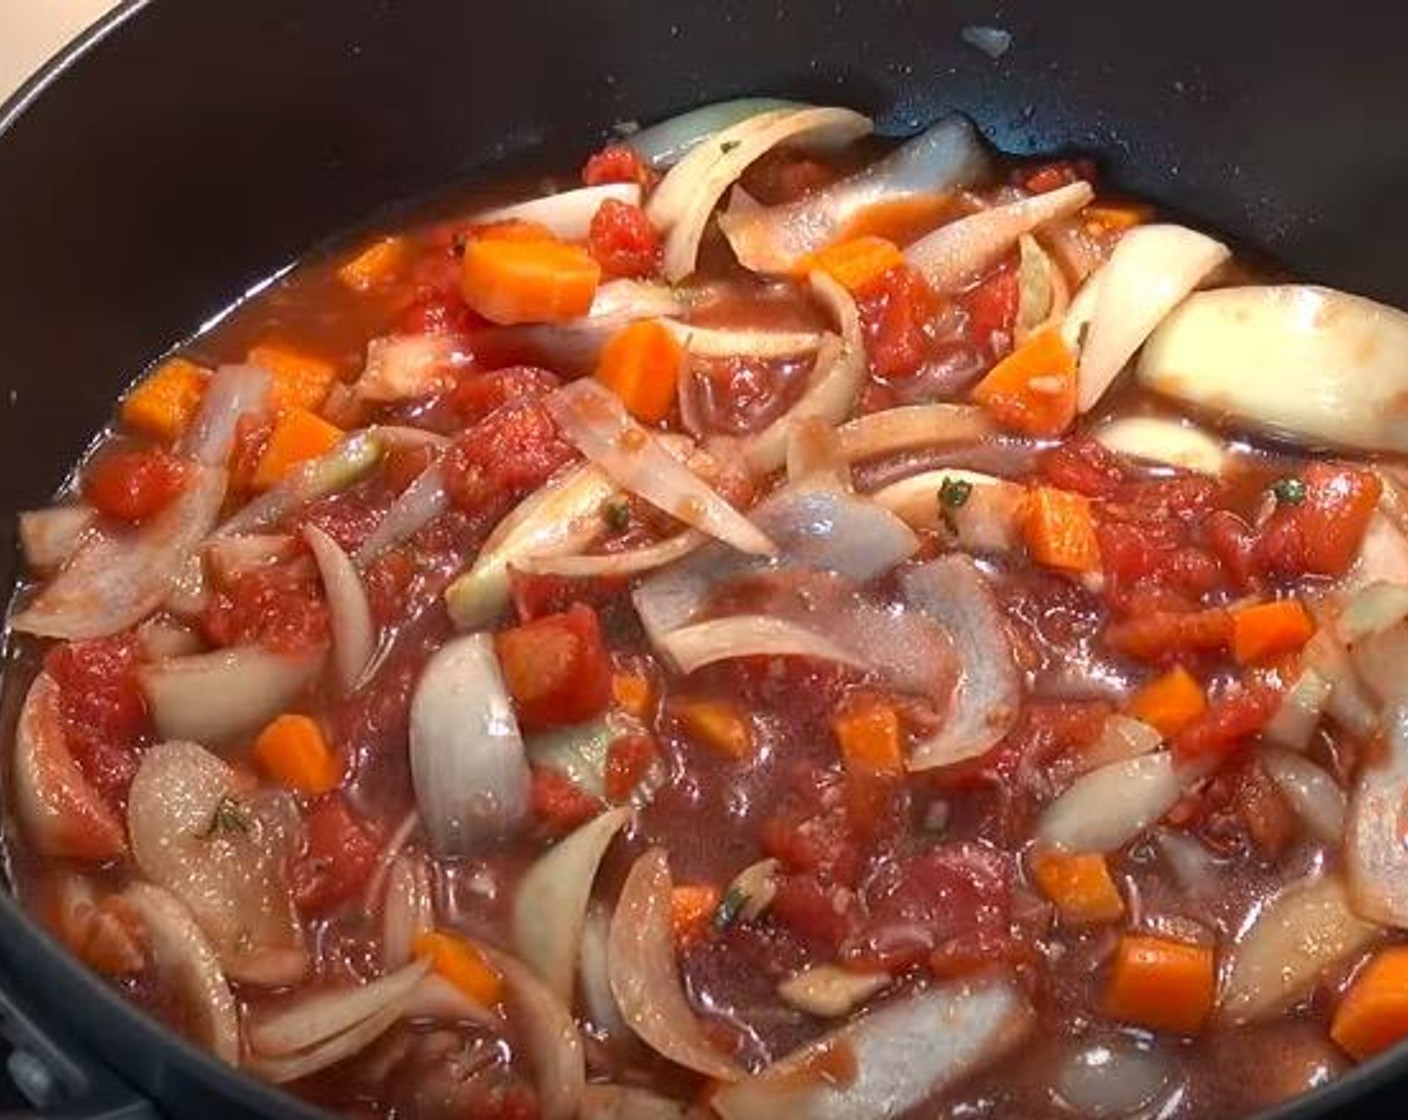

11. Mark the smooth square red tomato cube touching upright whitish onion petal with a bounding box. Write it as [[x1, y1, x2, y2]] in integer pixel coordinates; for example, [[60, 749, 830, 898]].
[[494, 604, 611, 730]]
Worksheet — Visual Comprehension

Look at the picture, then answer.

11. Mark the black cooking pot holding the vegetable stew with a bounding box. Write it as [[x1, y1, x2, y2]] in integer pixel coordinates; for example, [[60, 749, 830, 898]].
[[0, 0, 1408, 1120]]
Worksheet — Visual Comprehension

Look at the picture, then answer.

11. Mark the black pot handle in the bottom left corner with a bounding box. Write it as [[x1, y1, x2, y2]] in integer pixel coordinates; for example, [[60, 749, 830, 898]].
[[0, 985, 161, 1120]]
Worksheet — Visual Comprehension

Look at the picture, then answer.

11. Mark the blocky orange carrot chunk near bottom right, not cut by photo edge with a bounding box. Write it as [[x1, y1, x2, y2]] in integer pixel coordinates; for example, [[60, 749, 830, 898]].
[[1105, 934, 1217, 1034]]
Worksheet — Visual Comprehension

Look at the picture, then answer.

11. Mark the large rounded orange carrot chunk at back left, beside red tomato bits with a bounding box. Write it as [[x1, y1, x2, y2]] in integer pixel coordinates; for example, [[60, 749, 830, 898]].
[[459, 237, 601, 324]]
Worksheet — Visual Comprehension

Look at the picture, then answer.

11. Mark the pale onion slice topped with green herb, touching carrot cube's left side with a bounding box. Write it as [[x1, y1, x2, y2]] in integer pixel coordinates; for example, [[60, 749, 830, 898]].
[[870, 471, 1026, 552]]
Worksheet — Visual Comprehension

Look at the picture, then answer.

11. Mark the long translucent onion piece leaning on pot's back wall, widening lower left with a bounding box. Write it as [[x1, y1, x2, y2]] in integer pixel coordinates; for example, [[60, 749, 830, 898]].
[[718, 116, 990, 273]]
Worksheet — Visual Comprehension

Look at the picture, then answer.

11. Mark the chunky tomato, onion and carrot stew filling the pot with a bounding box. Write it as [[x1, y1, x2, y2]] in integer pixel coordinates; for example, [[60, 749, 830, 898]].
[[8, 101, 1408, 1120]]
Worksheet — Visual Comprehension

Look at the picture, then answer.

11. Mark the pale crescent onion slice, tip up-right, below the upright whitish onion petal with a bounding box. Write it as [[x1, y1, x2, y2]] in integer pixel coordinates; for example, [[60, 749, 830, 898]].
[[513, 809, 632, 1003]]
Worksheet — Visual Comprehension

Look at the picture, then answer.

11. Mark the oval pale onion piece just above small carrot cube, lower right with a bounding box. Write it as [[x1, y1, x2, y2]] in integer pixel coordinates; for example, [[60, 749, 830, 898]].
[[1036, 751, 1183, 852]]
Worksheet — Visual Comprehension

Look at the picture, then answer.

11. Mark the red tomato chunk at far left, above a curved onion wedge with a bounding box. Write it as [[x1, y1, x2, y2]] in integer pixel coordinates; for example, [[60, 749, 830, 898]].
[[44, 634, 152, 809]]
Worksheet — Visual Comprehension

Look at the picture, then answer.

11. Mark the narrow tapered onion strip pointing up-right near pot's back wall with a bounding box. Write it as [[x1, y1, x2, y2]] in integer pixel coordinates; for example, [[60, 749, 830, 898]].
[[904, 180, 1095, 293]]
